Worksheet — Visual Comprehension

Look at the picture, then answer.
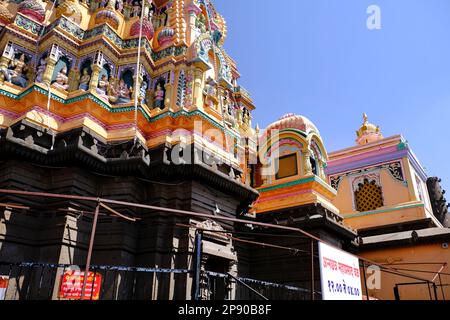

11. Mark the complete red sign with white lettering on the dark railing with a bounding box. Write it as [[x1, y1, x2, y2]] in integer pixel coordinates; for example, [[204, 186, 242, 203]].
[[59, 270, 102, 300]]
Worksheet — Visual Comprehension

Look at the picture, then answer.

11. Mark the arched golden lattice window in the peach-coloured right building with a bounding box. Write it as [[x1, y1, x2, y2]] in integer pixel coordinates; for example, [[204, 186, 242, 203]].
[[355, 179, 384, 212]]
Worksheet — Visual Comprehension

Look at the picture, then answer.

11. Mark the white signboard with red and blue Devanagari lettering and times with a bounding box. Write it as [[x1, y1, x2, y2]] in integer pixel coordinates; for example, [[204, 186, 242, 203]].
[[319, 242, 362, 300]]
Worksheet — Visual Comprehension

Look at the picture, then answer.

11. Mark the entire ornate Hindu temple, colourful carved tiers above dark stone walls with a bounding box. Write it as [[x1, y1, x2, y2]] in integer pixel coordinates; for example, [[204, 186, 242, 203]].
[[0, 0, 450, 300]]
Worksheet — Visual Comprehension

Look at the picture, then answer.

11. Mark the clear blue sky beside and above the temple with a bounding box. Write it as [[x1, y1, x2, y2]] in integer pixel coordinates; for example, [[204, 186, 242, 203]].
[[214, 0, 450, 192]]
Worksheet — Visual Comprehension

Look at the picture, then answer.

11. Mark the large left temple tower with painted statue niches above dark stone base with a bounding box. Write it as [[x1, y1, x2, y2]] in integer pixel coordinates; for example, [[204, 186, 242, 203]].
[[0, 0, 258, 299]]
